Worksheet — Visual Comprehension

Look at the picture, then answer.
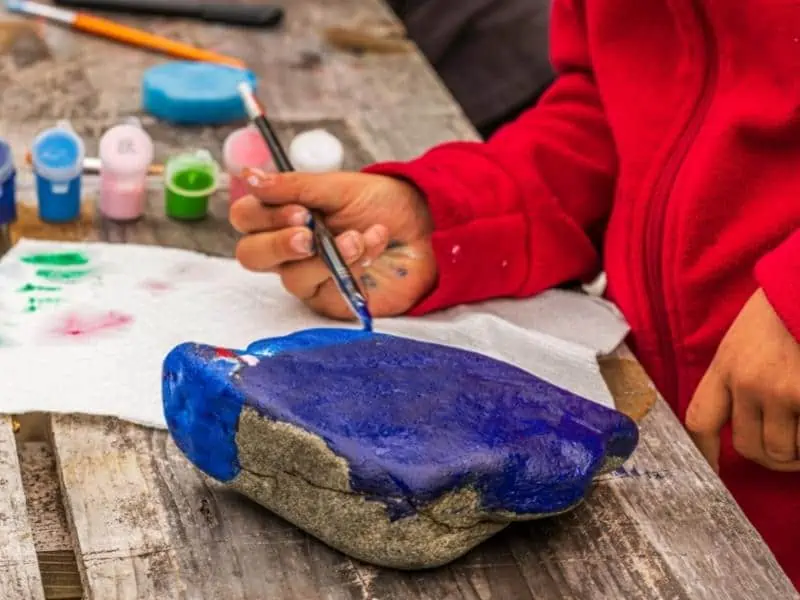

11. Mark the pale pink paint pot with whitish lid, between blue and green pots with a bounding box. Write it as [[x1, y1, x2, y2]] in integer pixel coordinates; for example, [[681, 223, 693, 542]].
[[99, 119, 154, 221]]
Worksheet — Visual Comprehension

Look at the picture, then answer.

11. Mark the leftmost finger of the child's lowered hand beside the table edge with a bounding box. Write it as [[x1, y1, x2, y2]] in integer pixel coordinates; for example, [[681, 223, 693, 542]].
[[686, 370, 732, 472]]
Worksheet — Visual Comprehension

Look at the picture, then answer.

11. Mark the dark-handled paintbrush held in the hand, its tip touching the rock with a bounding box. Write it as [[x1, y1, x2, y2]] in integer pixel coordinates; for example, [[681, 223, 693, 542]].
[[239, 82, 372, 331]]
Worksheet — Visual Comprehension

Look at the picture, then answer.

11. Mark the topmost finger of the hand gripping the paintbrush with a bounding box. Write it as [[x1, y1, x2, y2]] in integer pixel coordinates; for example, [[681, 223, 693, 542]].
[[242, 169, 359, 213]]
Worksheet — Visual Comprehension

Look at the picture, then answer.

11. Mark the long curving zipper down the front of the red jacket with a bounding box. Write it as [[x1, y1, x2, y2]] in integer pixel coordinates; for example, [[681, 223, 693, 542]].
[[644, 0, 717, 406]]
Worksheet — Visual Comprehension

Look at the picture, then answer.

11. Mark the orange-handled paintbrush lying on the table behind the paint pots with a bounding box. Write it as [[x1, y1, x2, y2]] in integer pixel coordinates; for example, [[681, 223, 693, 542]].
[[6, 0, 245, 69]]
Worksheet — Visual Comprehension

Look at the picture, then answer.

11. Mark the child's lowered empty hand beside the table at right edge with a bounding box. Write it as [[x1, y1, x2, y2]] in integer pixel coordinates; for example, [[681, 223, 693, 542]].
[[686, 290, 800, 471]]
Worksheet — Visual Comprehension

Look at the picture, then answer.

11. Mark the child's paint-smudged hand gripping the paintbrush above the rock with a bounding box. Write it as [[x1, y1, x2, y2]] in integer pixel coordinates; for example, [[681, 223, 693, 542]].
[[230, 166, 436, 319]]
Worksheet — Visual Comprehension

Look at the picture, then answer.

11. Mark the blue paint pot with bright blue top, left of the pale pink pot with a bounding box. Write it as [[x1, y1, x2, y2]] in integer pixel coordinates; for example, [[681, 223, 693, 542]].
[[31, 121, 85, 223]]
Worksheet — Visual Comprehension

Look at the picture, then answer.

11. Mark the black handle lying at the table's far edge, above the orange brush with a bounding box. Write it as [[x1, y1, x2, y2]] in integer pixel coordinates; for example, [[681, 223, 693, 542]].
[[54, 0, 283, 27]]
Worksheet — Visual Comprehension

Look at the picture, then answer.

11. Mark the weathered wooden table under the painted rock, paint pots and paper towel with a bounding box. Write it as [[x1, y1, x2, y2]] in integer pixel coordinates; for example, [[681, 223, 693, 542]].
[[0, 0, 799, 600]]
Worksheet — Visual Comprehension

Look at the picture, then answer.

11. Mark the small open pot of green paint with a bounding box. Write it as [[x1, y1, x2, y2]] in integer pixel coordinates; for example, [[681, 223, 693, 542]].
[[164, 150, 219, 221]]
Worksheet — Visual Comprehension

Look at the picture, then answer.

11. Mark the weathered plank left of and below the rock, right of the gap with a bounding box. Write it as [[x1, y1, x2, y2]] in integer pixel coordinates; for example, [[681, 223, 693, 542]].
[[52, 417, 370, 600]]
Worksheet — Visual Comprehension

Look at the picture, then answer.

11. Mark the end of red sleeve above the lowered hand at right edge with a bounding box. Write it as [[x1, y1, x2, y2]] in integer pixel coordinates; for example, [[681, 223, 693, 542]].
[[755, 231, 800, 342]]
